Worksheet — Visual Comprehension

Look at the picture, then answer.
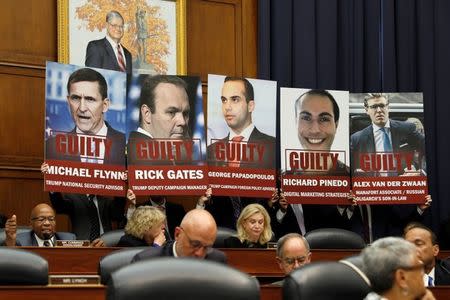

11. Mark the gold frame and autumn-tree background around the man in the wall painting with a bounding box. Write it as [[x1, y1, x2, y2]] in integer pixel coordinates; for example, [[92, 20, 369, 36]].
[[58, 0, 187, 75]]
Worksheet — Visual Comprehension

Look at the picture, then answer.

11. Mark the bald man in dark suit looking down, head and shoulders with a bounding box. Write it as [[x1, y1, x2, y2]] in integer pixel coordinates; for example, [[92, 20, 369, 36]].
[[132, 209, 226, 263]]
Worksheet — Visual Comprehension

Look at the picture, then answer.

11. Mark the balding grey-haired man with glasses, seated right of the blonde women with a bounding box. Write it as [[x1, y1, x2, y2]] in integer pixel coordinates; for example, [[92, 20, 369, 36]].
[[272, 233, 311, 286]]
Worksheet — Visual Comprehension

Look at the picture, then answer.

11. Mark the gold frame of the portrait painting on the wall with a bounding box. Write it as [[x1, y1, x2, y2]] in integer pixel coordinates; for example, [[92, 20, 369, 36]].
[[57, 0, 187, 75]]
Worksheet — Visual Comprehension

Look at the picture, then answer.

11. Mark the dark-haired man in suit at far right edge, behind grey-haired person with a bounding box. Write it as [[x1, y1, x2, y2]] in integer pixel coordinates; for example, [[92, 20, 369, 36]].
[[404, 222, 450, 286]]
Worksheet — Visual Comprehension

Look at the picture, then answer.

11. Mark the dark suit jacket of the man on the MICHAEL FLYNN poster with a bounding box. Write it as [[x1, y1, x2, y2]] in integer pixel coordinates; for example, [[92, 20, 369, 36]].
[[45, 122, 125, 166]]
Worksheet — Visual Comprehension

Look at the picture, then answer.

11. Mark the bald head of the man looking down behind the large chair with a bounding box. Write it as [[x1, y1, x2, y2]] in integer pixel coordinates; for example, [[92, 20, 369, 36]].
[[175, 209, 217, 258]]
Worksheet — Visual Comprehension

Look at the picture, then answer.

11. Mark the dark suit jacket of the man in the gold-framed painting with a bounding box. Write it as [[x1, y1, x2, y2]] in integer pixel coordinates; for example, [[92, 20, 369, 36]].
[[84, 37, 133, 74]]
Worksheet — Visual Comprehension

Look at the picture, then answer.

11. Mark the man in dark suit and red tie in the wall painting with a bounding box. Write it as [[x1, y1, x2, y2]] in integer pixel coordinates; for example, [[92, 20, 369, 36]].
[[85, 10, 132, 73]]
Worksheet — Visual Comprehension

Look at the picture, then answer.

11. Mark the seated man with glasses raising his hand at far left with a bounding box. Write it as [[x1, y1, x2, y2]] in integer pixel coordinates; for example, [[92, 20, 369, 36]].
[[5, 203, 104, 247]]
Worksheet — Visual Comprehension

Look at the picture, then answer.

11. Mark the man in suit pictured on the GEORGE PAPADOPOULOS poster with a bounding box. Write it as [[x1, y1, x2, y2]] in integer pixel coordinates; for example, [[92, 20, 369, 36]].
[[208, 75, 276, 169]]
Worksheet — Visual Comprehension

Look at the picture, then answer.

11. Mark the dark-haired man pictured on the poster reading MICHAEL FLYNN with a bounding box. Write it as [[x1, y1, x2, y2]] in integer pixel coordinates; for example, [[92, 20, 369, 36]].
[[46, 68, 125, 166]]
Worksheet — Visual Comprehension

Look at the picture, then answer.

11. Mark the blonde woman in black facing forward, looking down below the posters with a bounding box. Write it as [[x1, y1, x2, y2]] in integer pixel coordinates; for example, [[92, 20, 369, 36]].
[[224, 204, 272, 248]]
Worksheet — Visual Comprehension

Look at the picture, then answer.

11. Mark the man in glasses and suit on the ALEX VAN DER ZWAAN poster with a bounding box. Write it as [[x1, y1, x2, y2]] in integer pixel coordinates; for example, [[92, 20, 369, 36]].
[[350, 93, 425, 176]]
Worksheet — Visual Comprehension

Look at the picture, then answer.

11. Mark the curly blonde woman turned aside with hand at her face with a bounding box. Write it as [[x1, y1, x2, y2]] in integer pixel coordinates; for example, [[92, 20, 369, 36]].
[[117, 205, 166, 247]]
